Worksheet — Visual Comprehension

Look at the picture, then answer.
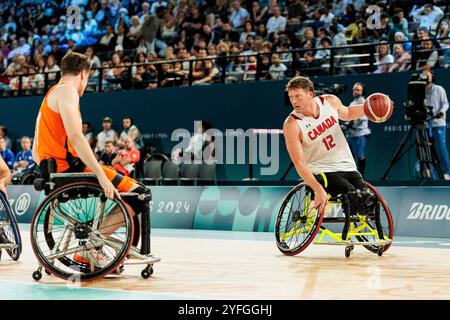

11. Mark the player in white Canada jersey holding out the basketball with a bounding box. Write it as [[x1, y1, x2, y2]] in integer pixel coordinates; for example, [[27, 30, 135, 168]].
[[283, 76, 393, 210]]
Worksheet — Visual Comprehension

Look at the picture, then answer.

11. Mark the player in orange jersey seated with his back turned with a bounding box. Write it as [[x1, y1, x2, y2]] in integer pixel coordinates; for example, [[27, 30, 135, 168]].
[[33, 51, 151, 267]]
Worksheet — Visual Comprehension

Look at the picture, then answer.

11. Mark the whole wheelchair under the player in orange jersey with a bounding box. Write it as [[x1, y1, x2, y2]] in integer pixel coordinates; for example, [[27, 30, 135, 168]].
[[31, 161, 160, 282]]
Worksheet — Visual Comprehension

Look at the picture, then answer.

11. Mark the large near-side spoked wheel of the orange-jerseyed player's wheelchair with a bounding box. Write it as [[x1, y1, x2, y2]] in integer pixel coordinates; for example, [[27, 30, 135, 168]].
[[31, 182, 134, 282]]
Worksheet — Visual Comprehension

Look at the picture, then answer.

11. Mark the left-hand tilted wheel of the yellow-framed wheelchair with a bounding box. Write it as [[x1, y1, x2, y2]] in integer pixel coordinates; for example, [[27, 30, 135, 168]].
[[275, 183, 323, 256]]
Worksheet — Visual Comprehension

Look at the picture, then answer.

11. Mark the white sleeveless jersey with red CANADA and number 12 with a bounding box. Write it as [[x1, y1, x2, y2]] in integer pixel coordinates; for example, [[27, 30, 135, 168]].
[[291, 96, 357, 174]]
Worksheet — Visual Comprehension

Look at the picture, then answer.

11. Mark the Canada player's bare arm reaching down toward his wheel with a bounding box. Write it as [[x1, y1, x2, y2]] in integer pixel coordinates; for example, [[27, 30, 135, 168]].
[[283, 116, 328, 210]]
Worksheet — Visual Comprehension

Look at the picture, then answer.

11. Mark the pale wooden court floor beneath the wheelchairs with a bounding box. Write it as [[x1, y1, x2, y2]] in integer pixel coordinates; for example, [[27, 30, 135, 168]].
[[0, 228, 450, 300]]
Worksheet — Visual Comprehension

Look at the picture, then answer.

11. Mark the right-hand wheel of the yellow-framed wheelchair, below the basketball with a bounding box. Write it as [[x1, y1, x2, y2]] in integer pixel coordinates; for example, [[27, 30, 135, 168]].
[[356, 182, 394, 255]]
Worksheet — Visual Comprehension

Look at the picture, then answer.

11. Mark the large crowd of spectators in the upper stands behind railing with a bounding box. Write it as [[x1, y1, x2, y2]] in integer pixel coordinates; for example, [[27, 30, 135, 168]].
[[0, 0, 450, 94]]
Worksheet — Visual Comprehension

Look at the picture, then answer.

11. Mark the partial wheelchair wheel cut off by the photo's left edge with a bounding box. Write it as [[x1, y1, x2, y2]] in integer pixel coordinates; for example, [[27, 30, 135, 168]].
[[0, 191, 22, 261]]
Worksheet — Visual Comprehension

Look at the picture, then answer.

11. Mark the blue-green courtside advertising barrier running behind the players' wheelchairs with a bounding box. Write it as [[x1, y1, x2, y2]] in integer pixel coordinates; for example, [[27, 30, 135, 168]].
[[8, 186, 450, 238]]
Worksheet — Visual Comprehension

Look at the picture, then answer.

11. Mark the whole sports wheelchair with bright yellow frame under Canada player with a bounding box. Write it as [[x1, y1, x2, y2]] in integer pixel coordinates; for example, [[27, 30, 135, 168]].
[[275, 182, 394, 257]]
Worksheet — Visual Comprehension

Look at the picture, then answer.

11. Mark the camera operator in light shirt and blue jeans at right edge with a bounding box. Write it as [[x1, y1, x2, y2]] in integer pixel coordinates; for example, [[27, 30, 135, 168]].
[[422, 70, 450, 180]]
